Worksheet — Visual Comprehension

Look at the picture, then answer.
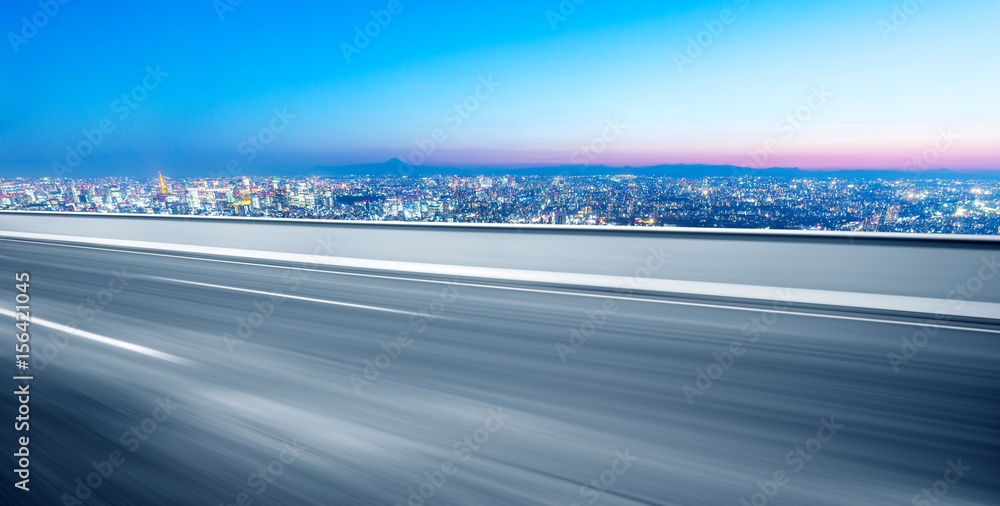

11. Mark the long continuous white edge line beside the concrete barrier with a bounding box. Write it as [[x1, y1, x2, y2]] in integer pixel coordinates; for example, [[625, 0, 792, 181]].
[[0, 238, 1000, 334]]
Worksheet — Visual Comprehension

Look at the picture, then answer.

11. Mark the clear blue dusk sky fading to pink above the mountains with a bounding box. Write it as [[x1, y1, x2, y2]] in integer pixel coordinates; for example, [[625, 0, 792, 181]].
[[0, 0, 1000, 177]]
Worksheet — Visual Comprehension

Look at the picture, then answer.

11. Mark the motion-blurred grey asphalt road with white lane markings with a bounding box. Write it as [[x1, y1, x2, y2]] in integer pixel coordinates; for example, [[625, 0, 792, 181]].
[[0, 240, 1000, 506]]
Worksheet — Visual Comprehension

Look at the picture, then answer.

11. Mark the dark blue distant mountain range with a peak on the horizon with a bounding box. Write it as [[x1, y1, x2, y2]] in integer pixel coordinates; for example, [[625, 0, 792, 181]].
[[306, 162, 1000, 179]]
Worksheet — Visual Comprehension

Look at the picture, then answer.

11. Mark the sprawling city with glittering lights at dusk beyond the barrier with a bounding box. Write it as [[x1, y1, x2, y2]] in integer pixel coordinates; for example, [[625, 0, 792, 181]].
[[0, 175, 1000, 235]]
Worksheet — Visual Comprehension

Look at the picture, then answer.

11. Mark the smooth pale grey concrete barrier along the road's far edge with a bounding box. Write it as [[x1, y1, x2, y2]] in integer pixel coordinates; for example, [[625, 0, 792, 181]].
[[0, 212, 1000, 319]]
